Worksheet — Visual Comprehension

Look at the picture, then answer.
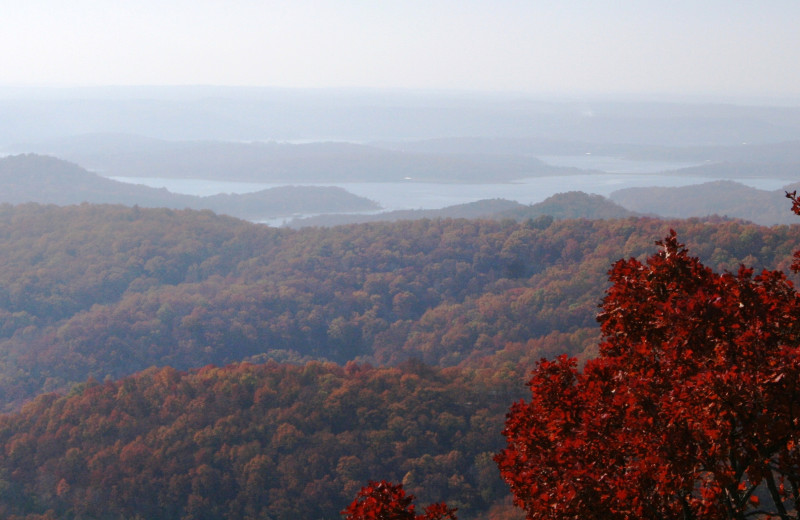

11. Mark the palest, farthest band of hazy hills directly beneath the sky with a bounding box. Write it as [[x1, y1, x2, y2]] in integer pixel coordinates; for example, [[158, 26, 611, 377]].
[[0, 87, 800, 145]]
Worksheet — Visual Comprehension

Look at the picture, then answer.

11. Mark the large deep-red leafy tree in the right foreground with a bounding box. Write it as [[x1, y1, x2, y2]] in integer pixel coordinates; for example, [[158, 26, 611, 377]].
[[495, 198, 800, 520]]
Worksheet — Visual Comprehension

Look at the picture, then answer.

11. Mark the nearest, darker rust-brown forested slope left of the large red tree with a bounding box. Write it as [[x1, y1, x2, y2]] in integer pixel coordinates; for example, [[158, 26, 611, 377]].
[[0, 363, 519, 520]]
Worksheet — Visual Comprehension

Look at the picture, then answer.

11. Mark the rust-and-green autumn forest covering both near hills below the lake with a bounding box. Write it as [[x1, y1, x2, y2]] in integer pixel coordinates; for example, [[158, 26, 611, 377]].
[[0, 198, 800, 519]]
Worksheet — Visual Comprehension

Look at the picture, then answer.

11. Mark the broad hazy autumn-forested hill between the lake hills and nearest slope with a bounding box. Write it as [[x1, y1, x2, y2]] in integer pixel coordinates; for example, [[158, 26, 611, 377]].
[[0, 204, 800, 407]]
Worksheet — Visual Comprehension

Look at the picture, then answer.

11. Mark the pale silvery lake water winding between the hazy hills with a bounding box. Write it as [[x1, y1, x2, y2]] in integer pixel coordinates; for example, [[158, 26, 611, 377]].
[[112, 173, 797, 211]]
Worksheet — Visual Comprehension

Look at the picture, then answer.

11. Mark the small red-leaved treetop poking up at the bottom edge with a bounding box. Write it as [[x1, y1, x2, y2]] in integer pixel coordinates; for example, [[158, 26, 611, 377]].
[[342, 480, 457, 520]]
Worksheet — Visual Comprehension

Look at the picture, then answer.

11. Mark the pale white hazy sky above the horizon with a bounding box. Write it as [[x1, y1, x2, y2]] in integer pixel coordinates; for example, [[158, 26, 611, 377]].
[[0, 0, 800, 99]]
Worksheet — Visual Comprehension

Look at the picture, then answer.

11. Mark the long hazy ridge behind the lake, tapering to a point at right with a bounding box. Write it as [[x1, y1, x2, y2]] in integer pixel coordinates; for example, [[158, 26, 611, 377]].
[[12, 136, 575, 183]]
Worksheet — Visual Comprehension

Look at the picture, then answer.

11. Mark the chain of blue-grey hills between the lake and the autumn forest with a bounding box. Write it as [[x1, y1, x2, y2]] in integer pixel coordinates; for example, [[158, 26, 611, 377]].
[[0, 155, 797, 227]]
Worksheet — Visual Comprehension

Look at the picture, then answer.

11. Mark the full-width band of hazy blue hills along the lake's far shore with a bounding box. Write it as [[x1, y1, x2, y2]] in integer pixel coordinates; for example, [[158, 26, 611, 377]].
[[11, 134, 800, 183]]
